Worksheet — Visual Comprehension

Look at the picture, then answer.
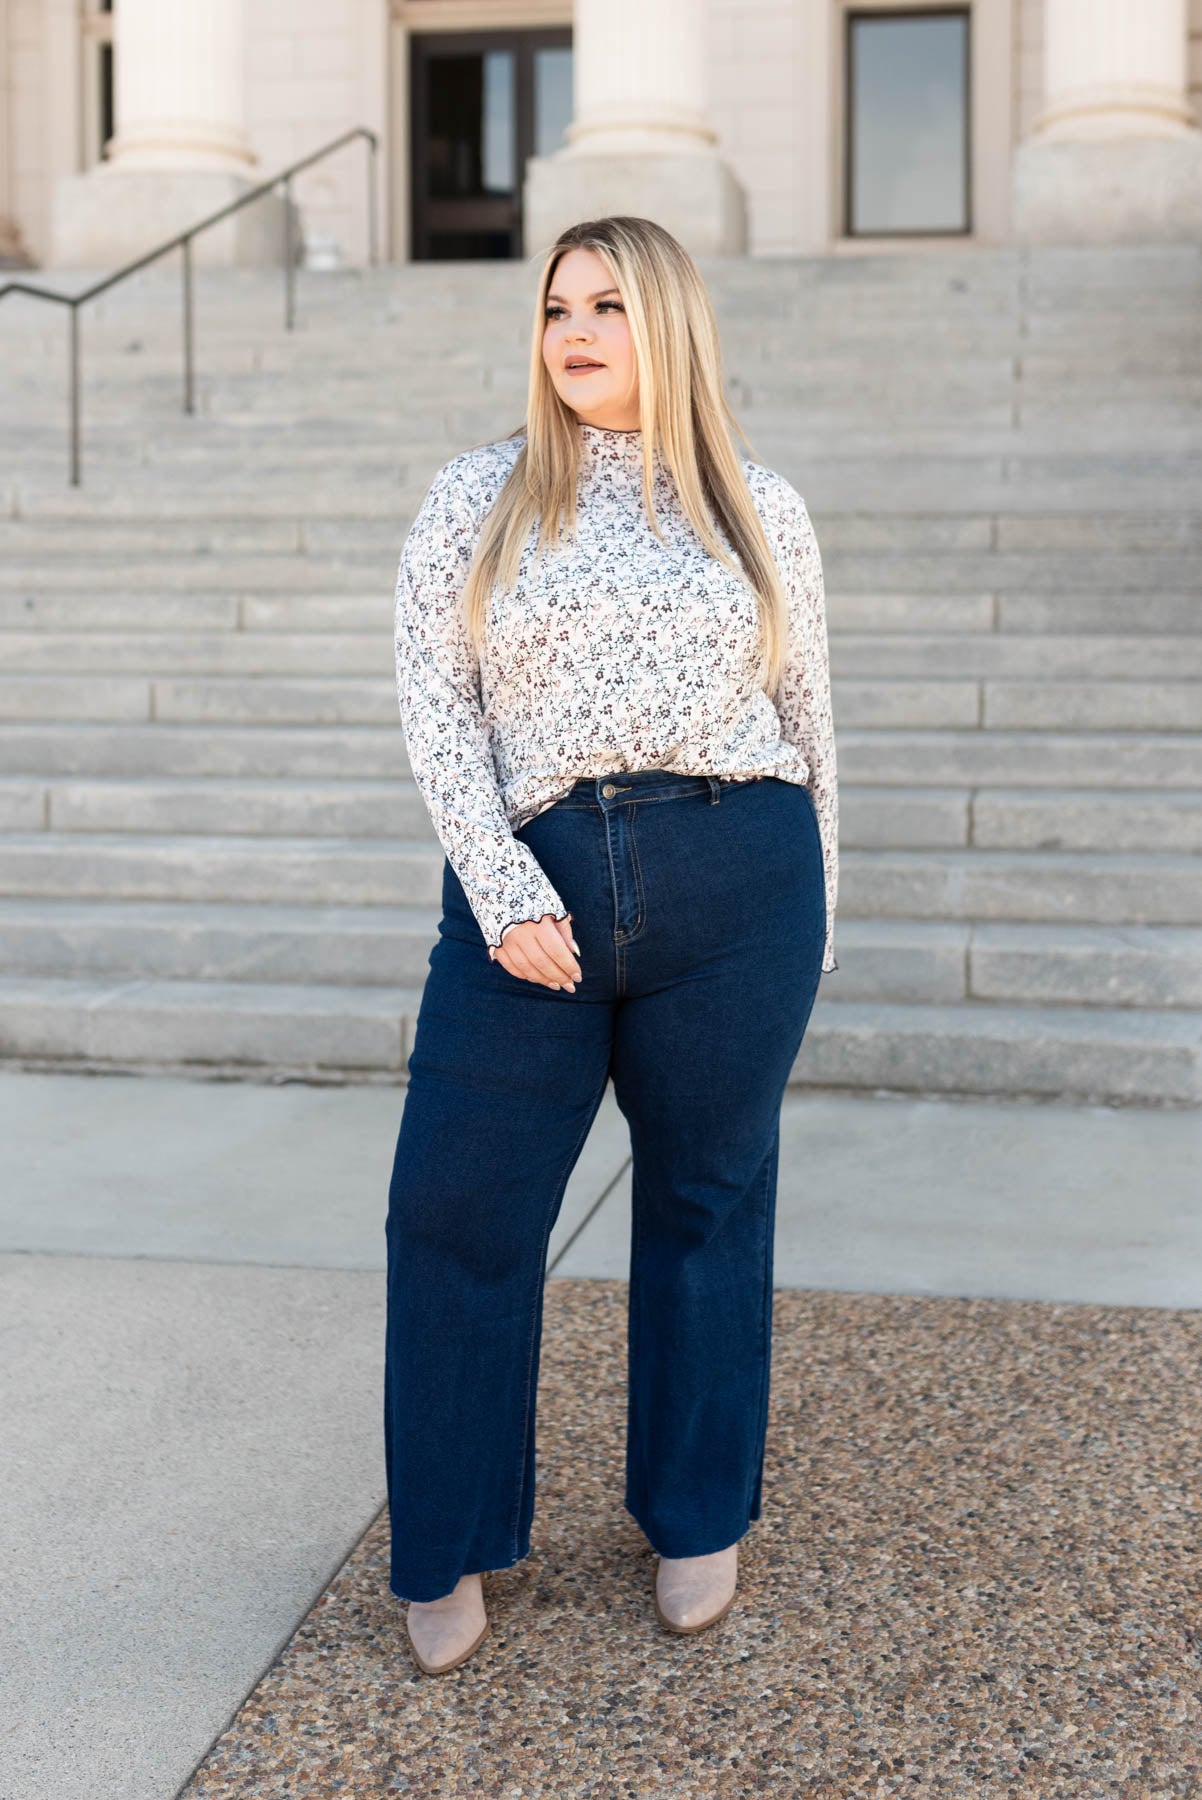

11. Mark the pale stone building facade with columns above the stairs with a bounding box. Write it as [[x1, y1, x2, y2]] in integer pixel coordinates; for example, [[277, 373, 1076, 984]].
[[0, 0, 1202, 268]]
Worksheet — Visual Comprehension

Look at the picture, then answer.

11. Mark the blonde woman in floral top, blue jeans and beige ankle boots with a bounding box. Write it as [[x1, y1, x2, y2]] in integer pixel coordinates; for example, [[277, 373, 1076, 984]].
[[385, 216, 839, 1674]]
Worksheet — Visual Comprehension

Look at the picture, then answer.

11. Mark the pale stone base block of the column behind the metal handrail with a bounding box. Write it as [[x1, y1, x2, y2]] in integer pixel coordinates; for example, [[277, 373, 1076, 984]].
[[49, 162, 301, 270]]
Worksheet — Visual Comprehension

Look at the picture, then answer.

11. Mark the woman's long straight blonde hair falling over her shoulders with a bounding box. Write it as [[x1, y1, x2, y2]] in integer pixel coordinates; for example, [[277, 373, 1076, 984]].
[[461, 214, 788, 698]]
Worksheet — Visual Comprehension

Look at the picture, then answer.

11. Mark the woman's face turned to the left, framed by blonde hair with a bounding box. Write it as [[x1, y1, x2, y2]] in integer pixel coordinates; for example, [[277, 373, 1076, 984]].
[[543, 250, 639, 432]]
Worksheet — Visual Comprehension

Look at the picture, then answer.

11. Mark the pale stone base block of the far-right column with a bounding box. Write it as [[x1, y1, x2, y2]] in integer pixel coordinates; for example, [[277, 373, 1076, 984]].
[[1013, 131, 1202, 245]]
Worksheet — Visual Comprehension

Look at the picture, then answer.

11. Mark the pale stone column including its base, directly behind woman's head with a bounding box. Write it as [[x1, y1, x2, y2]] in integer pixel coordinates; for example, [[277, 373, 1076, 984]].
[[524, 0, 747, 256]]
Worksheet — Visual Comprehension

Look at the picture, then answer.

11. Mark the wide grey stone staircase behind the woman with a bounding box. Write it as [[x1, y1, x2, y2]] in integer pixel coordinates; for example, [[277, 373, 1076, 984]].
[[0, 247, 1202, 1105]]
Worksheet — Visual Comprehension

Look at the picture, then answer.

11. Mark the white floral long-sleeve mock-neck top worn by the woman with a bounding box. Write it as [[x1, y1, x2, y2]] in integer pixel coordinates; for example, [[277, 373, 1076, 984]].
[[396, 421, 839, 974]]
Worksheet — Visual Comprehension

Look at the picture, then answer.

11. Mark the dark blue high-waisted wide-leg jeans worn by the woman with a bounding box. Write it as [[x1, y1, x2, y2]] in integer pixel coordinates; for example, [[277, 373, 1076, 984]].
[[383, 769, 826, 1600]]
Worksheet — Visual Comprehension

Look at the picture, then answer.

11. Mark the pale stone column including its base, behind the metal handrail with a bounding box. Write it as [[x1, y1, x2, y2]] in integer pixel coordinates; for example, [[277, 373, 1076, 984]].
[[54, 0, 284, 268]]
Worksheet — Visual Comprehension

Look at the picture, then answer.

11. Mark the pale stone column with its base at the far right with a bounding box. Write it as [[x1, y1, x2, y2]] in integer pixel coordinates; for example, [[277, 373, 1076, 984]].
[[1015, 0, 1202, 243]]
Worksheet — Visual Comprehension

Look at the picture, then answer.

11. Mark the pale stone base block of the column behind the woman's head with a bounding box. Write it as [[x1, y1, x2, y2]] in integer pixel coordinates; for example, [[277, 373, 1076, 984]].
[[524, 149, 747, 256]]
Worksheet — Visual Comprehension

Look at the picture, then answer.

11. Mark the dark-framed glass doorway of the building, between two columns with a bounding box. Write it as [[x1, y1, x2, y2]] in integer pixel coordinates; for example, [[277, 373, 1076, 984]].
[[408, 27, 572, 261]]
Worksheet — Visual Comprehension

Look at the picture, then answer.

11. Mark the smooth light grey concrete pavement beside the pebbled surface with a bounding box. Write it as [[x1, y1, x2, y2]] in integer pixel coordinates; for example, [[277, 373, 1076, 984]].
[[0, 1071, 1202, 1800]]
